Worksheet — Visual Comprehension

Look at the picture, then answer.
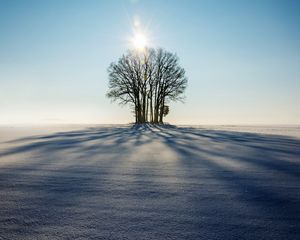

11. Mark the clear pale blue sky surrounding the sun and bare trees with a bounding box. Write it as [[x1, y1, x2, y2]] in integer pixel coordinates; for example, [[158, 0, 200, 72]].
[[0, 0, 300, 124]]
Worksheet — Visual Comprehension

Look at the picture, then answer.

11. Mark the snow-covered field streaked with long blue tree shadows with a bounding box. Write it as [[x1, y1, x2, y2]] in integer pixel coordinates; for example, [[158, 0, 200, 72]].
[[0, 125, 300, 239]]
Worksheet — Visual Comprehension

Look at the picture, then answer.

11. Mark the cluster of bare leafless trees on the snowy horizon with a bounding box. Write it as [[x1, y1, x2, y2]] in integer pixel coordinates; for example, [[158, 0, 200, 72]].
[[107, 49, 187, 123]]
